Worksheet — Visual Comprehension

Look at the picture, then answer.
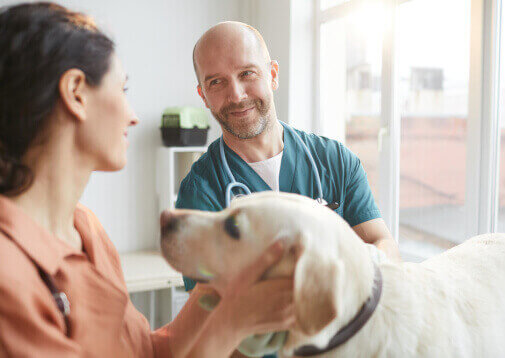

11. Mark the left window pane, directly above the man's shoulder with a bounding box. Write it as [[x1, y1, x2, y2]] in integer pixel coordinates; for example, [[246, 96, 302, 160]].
[[319, 4, 383, 198]]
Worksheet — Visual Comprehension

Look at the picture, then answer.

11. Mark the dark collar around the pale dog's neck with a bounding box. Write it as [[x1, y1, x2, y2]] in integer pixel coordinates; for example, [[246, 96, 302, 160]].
[[295, 263, 382, 357]]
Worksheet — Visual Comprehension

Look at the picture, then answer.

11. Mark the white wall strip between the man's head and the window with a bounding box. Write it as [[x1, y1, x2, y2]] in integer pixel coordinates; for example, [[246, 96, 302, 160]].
[[250, 0, 314, 131]]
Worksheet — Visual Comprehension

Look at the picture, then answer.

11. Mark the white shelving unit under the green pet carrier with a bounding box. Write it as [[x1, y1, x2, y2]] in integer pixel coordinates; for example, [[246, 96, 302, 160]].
[[156, 147, 207, 213]]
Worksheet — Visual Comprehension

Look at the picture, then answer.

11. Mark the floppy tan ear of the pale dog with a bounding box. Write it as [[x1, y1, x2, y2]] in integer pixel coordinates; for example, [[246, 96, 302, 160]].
[[294, 244, 343, 336]]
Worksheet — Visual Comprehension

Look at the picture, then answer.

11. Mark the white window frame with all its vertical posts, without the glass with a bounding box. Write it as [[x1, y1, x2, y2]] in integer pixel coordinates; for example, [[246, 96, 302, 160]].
[[312, 0, 502, 246]]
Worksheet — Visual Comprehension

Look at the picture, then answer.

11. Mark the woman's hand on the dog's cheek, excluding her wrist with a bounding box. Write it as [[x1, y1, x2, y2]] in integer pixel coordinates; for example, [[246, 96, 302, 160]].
[[211, 242, 295, 340]]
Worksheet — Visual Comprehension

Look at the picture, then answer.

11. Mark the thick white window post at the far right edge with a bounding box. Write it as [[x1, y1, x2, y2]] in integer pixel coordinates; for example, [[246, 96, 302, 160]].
[[466, 0, 501, 237]]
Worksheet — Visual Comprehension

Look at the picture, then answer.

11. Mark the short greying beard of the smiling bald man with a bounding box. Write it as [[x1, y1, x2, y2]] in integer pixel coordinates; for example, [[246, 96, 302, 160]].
[[211, 99, 270, 139]]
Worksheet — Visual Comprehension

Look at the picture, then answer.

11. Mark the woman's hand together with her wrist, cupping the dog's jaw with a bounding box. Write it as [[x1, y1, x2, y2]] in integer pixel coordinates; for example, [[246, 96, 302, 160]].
[[182, 242, 295, 358]]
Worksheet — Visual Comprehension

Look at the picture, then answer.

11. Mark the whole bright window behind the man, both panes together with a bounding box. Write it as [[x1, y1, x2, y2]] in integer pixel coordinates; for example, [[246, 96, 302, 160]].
[[315, 0, 478, 261]]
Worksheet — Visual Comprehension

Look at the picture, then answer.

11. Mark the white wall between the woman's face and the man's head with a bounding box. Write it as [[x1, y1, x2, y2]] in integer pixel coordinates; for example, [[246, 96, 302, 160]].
[[0, 0, 250, 252]]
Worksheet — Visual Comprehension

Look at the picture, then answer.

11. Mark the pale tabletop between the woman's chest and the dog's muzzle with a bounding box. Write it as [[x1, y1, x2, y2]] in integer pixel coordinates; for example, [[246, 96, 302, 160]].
[[119, 251, 184, 293]]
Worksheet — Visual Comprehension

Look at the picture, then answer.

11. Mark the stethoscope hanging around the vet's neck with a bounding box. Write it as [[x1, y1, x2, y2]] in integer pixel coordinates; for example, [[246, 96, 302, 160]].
[[219, 125, 339, 210]]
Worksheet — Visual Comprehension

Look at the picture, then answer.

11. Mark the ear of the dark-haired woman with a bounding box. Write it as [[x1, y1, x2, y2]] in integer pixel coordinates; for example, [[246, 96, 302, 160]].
[[58, 68, 87, 121]]
